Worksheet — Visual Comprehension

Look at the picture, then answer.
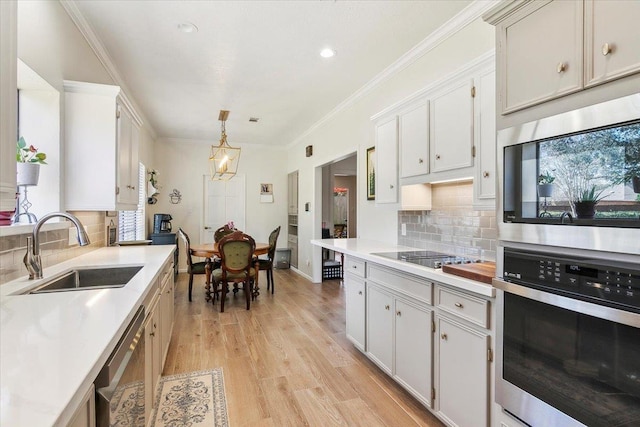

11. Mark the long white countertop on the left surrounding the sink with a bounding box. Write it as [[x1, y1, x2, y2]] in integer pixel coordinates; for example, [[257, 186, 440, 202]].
[[0, 245, 175, 427]]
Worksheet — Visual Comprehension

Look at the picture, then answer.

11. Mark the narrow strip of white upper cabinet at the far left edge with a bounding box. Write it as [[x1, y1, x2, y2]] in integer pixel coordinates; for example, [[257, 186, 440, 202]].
[[0, 1, 18, 212]]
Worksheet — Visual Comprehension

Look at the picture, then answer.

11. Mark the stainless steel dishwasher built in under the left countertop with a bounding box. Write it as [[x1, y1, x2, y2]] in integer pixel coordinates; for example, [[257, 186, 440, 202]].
[[95, 306, 146, 427]]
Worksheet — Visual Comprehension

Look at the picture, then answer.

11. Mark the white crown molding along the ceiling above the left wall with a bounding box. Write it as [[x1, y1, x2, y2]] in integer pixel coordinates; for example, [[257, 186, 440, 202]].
[[60, 0, 158, 140]]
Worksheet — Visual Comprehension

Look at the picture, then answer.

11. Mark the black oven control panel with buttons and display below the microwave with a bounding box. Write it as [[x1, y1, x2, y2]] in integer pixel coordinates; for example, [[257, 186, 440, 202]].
[[503, 249, 640, 311]]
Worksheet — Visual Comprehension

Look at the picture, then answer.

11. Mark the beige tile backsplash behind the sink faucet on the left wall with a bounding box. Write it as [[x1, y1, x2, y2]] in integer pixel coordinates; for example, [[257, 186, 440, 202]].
[[0, 211, 106, 285]]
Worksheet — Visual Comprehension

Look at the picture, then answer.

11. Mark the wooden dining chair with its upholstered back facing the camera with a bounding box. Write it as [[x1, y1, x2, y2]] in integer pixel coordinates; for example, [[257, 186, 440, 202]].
[[212, 231, 258, 313]]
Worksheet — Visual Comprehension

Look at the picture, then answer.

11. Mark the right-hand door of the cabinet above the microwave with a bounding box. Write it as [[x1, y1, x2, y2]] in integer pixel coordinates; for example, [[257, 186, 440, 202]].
[[585, 0, 640, 86]]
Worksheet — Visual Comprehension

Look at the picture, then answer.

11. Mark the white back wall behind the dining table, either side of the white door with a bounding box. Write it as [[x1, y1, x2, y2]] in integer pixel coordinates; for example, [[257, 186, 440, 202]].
[[147, 139, 287, 271]]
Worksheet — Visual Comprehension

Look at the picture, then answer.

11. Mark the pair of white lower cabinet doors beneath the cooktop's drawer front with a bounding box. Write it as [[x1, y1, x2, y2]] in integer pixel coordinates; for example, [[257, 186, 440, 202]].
[[366, 282, 433, 407]]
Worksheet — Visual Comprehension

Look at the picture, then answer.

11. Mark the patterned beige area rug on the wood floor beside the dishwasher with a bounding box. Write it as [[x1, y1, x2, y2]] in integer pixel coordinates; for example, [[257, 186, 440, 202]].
[[151, 368, 229, 427]]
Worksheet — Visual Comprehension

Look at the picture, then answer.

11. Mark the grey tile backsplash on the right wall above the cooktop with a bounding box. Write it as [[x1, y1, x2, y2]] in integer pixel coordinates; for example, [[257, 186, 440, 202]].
[[398, 182, 497, 261]]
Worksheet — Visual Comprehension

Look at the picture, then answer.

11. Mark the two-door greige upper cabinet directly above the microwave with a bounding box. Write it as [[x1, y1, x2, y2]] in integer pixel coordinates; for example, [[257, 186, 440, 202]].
[[484, 0, 640, 114]]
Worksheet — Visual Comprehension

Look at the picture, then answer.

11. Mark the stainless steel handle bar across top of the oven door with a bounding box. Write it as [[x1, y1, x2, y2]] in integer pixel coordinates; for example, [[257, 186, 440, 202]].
[[492, 278, 640, 328]]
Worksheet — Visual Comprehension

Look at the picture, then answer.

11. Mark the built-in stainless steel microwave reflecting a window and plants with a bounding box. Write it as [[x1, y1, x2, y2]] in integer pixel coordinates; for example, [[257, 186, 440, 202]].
[[497, 94, 640, 255]]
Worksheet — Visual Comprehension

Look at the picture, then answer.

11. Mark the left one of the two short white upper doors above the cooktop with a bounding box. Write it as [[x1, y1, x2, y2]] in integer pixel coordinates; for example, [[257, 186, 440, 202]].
[[399, 101, 429, 178]]
